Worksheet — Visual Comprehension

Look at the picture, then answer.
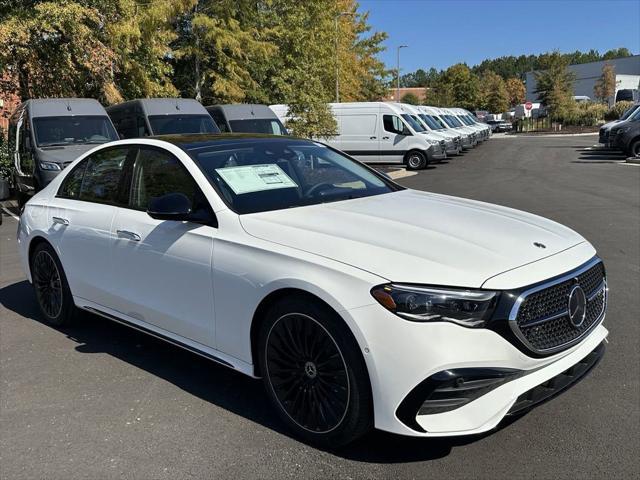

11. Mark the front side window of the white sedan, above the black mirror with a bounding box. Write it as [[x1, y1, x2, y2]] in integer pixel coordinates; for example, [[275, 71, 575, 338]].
[[130, 148, 198, 210]]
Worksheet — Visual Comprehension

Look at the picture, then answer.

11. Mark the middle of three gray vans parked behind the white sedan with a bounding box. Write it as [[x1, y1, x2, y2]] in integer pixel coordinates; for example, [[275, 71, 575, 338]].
[[107, 98, 220, 138]]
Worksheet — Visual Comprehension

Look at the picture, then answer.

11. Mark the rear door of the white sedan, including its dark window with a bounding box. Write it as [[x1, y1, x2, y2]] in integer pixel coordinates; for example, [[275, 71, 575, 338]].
[[48, 147, 135, 306]]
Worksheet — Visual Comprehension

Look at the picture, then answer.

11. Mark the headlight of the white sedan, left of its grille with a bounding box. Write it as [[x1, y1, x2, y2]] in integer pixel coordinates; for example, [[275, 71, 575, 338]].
[[371, 283, 498, 328]]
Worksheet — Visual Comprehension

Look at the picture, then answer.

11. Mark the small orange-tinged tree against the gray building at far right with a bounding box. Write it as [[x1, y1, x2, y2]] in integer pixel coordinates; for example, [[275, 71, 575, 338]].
[[535, 52, 575, 118]]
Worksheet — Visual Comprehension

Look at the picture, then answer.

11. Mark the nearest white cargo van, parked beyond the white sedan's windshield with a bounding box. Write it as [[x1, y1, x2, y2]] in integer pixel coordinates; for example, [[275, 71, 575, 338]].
[[270, 102, 447, 170]]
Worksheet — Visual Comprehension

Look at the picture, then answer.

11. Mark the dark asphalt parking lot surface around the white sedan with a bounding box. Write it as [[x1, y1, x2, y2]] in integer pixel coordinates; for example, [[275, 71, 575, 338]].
[[0, 136, 640, 479]]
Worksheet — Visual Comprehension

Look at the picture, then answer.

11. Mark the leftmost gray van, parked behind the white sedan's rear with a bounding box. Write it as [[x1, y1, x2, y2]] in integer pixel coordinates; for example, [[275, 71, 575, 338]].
[[9, 98, 118, 207]]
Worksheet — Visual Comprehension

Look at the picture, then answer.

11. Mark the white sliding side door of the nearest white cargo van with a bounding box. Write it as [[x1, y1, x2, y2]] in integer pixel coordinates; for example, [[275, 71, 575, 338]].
[[338, 113, 380, 163]]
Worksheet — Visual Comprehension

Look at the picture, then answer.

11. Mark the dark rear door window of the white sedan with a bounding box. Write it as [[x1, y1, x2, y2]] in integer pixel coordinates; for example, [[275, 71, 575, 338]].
[[79, 147, 131, 205]]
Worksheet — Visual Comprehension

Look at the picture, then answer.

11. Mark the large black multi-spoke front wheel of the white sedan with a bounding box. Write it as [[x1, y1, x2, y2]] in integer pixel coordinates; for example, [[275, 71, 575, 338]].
[[259, 297, 373, 447]]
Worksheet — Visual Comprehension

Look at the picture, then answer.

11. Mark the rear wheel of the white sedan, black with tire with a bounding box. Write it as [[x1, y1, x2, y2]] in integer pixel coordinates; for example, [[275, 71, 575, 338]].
[[29, 242, 76, 327]]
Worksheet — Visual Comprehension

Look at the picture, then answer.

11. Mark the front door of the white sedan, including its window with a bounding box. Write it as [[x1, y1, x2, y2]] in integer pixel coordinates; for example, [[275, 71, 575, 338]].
[[111, 146, 217, 347]]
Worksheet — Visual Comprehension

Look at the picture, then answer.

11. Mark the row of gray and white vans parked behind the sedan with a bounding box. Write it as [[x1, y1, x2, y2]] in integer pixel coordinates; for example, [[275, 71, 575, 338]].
[[9, 98, 490, 204]]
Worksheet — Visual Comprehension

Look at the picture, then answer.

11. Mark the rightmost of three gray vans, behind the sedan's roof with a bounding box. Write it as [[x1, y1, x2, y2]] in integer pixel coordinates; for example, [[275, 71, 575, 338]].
[[206, 103, 289, 135]]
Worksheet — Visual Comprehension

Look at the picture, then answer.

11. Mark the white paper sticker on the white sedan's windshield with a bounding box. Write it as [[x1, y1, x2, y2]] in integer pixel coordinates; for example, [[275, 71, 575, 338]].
[[216, 164, 298, 195]]
